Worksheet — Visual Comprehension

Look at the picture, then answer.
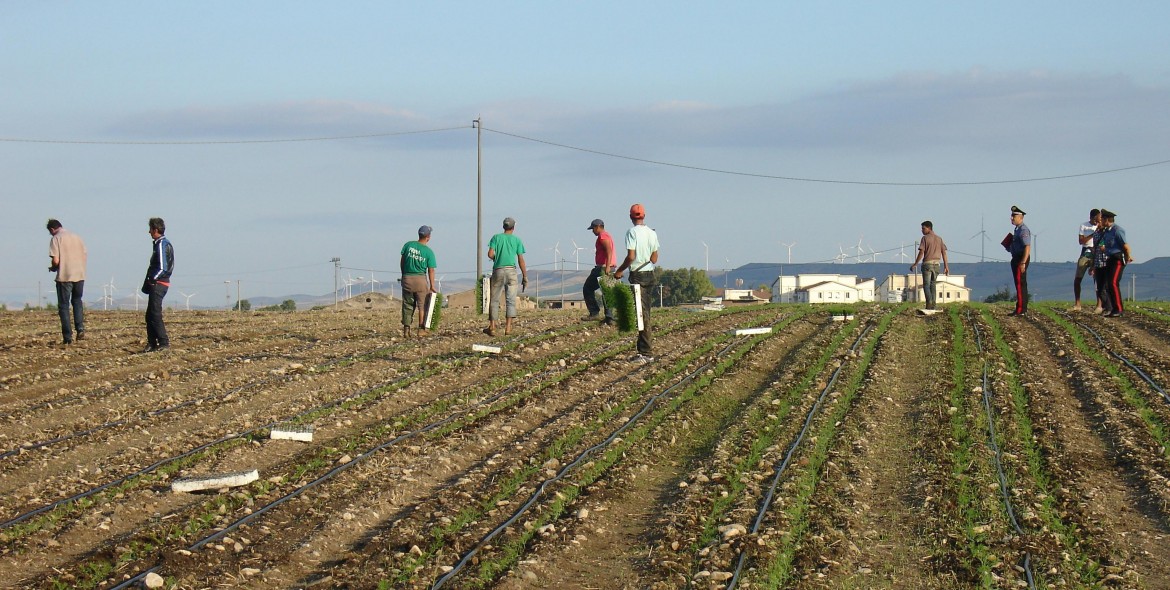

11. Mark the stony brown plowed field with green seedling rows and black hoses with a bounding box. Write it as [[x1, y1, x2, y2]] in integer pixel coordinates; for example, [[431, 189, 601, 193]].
[[0, 304, 1170, 589]]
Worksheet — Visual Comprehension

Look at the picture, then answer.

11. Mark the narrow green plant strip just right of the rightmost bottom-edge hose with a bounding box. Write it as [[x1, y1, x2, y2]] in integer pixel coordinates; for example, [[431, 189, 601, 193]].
[[982, 306, 1103, 585]]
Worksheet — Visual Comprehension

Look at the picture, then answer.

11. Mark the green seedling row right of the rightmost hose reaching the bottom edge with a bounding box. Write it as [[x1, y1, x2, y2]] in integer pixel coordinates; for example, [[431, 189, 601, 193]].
[[979, 306, 1104, 586]]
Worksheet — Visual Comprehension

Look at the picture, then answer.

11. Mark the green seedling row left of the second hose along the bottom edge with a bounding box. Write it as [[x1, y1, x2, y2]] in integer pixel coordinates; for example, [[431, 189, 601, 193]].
[[355, 310, 799, 588]]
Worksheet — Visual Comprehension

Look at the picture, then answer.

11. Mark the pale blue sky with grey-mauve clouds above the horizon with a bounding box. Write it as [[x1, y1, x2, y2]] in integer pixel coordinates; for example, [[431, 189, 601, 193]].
[[0, 0, 1170, 308]]
